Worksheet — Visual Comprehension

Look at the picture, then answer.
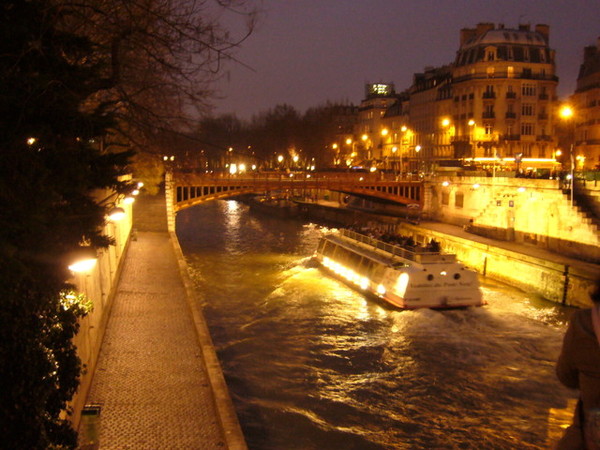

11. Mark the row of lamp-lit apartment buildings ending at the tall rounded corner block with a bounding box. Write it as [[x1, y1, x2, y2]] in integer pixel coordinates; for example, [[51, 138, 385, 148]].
[[354, 23, 560, 176]]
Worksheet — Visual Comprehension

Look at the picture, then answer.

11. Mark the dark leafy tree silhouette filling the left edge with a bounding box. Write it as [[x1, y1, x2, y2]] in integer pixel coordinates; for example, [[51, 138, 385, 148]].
[[0, 0, 130, 449]]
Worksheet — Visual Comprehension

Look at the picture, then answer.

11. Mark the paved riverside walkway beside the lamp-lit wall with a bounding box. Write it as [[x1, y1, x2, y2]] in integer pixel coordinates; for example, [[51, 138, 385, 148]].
[[84, 195, 246, 450]]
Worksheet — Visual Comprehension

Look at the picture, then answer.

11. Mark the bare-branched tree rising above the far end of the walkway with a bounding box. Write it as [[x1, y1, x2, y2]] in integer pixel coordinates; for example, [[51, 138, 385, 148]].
[[51, 0, 255, 186]]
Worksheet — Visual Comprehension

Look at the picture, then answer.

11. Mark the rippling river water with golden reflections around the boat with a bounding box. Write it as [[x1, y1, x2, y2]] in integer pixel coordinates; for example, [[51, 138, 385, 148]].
[[177, 200, 575, 450]]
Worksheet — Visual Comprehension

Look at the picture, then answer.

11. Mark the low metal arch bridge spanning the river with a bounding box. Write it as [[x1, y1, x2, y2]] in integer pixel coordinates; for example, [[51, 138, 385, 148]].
[[165, 170, 423, 230]]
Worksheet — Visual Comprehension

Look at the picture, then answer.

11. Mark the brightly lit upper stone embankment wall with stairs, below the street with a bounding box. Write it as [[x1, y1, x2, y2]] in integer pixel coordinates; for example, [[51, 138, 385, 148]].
[[424, 175, 600, 262]]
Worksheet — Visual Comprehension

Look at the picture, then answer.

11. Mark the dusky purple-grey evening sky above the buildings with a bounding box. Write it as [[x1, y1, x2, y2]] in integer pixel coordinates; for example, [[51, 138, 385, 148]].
[[213, 0, 600, 119]]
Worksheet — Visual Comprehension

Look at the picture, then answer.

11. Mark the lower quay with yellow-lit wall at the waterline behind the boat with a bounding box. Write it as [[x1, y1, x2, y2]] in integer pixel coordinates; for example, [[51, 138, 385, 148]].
[[290, 200, 600, 307]]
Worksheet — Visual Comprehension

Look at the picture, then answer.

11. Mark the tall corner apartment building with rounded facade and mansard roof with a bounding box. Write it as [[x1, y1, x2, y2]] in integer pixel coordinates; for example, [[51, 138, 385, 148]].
[[452, 24, 558, 166]]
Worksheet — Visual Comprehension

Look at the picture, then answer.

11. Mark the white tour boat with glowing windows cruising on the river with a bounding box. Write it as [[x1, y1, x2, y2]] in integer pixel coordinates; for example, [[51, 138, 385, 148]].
[[314, 230, 484, 309]]
